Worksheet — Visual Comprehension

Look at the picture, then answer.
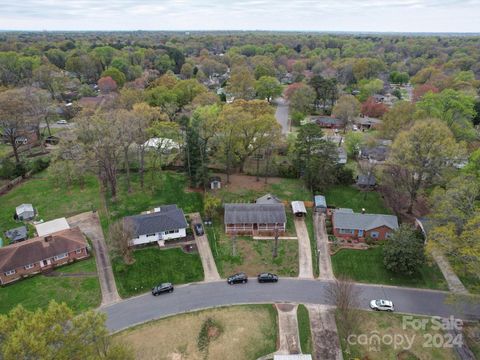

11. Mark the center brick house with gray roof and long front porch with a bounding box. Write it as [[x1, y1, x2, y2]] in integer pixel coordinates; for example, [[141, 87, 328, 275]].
[[224, 198, 287, 235]]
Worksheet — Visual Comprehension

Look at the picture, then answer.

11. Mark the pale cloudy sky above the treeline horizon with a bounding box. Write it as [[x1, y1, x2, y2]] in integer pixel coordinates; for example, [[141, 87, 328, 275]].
[[0, 0, 480, 32]]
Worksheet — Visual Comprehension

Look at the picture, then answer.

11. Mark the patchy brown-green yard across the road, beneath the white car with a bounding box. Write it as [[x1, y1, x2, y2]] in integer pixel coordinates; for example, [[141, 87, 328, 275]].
[[337, 311, 457, 360]]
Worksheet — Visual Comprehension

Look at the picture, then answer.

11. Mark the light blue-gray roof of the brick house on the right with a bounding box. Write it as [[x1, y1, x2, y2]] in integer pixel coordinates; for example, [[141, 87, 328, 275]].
[[333, 211, 398, 230]]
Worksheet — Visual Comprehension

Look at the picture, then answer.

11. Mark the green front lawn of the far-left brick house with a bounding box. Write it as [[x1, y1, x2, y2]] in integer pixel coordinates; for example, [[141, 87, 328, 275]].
[[0, 258, 101, 313]]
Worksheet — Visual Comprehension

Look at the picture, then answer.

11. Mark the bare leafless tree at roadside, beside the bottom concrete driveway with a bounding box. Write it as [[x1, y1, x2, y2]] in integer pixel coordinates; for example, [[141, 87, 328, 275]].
[[326, 277, 360, 336]]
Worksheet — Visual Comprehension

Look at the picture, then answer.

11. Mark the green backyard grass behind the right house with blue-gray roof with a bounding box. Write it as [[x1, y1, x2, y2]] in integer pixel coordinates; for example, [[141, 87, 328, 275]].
[[325, 185, 391, 214]]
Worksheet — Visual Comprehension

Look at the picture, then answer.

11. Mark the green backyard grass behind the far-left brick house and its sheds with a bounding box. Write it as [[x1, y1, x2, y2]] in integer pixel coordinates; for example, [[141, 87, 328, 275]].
[[0, 171, 100, 239]]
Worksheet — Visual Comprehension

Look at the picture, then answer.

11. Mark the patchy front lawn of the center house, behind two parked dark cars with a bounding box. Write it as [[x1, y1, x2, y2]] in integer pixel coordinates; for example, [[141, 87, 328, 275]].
[[206, 219, 298, 277]]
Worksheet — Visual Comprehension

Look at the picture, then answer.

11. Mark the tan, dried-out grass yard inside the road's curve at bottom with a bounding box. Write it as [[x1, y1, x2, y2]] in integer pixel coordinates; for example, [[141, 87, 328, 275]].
[[114, 305, 277, 360]]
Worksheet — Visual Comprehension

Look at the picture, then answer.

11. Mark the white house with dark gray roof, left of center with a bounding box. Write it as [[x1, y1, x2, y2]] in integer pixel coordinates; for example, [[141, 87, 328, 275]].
[[124, 205, 188, 246]]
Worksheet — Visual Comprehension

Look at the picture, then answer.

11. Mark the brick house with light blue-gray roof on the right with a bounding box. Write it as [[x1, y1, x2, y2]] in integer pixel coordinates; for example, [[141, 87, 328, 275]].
[[332, 209, 398, 240]]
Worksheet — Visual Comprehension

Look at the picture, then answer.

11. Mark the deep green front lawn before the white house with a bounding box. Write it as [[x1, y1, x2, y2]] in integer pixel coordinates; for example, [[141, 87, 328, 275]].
[[112, 247, 203, 297]]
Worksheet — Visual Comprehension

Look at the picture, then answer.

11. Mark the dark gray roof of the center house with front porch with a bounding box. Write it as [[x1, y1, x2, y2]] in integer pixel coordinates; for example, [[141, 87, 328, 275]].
[[224, 204, 287, 224]]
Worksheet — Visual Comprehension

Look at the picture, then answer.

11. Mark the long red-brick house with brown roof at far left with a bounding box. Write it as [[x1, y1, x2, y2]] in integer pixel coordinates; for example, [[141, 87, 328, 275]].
[[0, 227, 89, 284]]
